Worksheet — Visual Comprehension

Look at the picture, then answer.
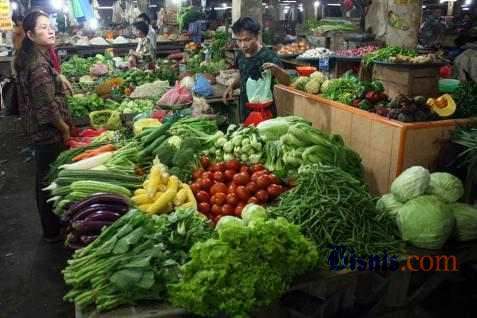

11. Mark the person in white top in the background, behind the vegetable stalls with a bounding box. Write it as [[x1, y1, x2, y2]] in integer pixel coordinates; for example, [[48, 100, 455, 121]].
[[129, 21, 155, 67]]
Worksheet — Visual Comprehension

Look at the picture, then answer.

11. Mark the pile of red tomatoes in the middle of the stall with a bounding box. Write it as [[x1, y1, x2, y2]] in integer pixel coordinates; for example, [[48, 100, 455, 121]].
[[191, 157, 286, 221]]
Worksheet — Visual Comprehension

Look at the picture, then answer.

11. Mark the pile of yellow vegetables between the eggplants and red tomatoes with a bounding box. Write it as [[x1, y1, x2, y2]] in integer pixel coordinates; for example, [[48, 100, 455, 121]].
[[131, 158, 197, 214]]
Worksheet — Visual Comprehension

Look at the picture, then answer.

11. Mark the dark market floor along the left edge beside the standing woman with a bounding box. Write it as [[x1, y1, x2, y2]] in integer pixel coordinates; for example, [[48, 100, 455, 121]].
[[0, 117, 74, 318]]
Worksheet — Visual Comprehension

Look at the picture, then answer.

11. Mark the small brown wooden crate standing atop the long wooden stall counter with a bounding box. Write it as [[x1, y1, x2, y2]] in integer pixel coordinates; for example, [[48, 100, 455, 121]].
[[373, 64, 440, 98]]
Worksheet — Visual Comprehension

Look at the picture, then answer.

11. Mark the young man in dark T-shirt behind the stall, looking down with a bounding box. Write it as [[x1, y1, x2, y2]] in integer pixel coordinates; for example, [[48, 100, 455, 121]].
[[223, 17, 290, 122]]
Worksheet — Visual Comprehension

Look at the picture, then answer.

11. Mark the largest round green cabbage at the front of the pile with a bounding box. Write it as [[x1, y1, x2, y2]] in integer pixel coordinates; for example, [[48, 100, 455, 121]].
[[398, 195, 455, 249]]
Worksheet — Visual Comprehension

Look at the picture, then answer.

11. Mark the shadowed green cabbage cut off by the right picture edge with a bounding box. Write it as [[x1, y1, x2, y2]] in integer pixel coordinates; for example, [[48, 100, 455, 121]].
[[451, 203, 477, 242]]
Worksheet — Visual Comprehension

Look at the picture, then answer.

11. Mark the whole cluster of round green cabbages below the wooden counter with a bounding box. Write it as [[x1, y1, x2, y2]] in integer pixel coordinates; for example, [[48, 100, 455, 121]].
[[377, 166, 477, 249]]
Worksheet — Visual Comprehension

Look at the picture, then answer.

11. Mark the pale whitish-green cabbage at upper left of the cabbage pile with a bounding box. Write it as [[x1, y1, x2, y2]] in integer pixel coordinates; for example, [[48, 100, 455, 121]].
[[391, 166, 431, 203]]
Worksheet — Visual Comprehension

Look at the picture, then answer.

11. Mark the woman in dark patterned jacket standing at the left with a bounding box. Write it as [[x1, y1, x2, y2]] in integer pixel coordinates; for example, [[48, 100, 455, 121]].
[[14, 11, 72, 242]]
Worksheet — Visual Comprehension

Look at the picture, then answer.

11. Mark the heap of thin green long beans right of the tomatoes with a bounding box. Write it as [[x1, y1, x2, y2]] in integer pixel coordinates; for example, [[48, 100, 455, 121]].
[[270, 165, 400, 256]]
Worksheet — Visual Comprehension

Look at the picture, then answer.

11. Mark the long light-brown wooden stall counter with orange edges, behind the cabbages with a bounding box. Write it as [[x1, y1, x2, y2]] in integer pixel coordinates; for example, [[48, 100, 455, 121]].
[[274, 85, 469, 194]]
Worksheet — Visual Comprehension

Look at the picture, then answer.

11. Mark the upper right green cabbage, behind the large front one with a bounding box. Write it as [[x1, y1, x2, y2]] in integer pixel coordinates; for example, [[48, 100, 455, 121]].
[[427, 172, 464, 203]]
